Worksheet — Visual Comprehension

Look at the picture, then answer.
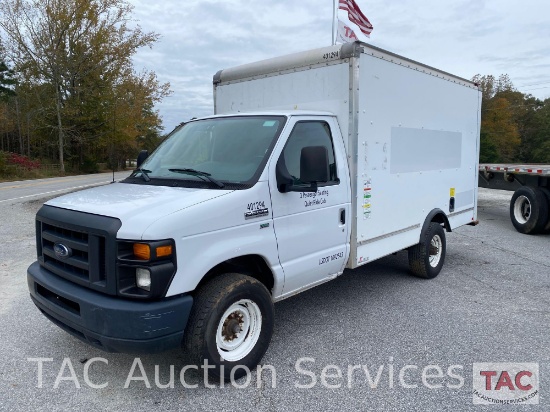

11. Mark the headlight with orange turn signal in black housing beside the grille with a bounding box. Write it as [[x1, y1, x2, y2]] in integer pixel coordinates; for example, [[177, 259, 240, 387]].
[[117, 239, 176, 299]]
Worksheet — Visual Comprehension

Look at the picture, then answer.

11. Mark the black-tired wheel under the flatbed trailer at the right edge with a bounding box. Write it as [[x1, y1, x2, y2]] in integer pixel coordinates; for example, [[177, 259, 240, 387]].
[[510, 186, 548, 235]]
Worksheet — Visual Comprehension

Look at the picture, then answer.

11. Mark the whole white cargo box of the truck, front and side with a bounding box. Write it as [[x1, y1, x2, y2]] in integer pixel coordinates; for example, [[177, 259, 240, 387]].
[[214, 42, 481, 267]]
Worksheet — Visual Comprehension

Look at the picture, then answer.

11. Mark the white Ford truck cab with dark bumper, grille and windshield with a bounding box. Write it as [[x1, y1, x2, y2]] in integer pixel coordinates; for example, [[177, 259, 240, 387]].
[[28, 112, 350, 380]]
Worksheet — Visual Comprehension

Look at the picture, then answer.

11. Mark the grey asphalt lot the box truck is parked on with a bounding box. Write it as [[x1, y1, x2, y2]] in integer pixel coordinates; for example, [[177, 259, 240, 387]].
[[0, 189, 550, 412]]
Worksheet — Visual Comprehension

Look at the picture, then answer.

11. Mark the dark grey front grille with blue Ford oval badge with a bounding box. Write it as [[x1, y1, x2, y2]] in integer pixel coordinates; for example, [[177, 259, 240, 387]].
[[36, 206, 121, 294]]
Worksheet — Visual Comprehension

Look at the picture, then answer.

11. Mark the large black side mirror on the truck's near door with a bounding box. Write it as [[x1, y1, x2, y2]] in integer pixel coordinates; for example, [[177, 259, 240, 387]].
[[275, 146, 330, 193]]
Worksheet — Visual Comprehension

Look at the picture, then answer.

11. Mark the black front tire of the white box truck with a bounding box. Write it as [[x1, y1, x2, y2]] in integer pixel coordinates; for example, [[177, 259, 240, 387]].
[[183, 273, 274, 382]]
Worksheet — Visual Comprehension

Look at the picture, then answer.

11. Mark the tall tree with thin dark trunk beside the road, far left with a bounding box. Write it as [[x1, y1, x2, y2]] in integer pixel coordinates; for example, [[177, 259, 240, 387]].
[[0, 0, 168, 171]]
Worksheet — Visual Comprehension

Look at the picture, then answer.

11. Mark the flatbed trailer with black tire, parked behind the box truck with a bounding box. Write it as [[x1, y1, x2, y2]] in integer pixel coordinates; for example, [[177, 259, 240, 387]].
[[478, 164, 550, 234]]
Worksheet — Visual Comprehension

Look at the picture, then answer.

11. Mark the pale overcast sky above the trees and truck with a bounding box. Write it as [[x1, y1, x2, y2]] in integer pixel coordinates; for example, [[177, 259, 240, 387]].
[[129, 0, 550, 132]]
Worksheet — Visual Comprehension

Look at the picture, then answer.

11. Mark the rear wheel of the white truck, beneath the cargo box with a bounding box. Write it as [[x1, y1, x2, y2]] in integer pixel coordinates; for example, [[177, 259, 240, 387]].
[[409, 222, 447, 279]]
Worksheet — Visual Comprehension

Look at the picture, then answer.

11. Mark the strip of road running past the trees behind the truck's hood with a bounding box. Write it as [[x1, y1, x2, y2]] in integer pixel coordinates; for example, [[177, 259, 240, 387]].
[[0, 171, 130, 204]]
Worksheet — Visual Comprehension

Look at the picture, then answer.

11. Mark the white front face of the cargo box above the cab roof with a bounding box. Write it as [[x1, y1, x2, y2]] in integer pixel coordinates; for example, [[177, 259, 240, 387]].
[[214, 46, 355, 136]]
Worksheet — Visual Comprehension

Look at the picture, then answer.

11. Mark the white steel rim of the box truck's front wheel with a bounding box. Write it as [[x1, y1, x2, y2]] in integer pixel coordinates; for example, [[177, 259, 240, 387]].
[[216, 299, 262, 362]]
